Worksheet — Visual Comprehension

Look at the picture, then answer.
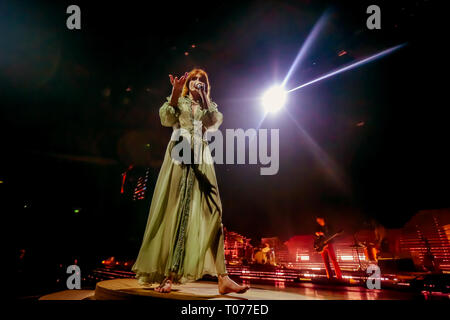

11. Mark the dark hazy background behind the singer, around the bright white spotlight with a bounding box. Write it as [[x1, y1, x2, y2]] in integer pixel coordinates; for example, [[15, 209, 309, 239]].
[[0, 1, 450, 296]]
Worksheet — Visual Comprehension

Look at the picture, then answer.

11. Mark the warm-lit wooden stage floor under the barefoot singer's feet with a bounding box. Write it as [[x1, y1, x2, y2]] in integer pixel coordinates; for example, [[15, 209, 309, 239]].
[[40, 279, 420, 301]]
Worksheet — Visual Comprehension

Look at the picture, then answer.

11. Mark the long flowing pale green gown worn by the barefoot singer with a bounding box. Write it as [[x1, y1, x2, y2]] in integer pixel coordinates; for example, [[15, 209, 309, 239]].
[[132, 96, 227, 284]]
